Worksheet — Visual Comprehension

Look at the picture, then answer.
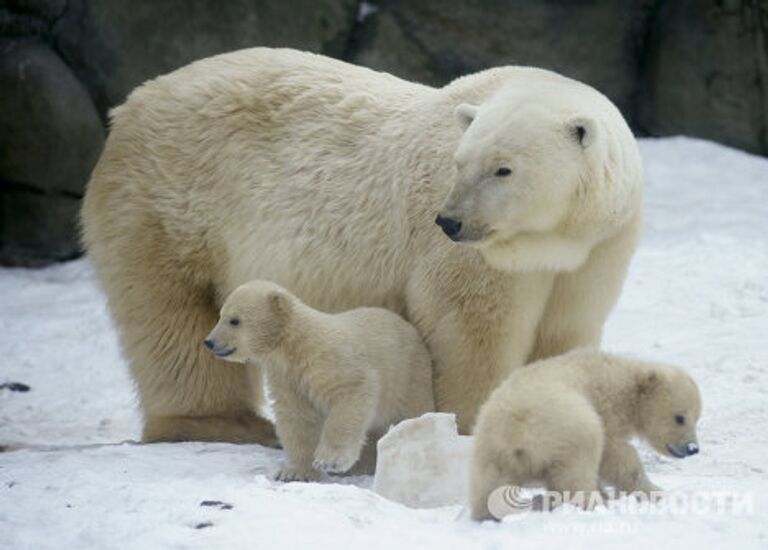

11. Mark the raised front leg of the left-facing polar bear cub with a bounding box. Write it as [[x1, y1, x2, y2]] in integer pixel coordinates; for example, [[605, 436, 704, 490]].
[[313, 381, 376, 473]]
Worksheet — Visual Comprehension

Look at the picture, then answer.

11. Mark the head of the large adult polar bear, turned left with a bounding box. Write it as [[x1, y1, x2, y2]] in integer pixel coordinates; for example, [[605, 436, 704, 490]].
[[436, 77, 642, 271]]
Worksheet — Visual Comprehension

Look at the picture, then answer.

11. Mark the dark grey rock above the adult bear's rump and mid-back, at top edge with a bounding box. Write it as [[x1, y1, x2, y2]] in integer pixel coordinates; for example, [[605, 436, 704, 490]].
[[54, 0, 357, 113]]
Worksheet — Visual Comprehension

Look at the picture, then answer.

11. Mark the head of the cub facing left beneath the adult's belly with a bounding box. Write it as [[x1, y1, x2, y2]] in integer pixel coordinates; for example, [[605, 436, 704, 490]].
[[203, 281, 293, 363]]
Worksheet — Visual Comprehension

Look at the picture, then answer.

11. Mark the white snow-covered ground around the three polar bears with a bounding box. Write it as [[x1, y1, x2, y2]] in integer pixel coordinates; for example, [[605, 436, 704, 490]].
[[0, 138, 768, 550]]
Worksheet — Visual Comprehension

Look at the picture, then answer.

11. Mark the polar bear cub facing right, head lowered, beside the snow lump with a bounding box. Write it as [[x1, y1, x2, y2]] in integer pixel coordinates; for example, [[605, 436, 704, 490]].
[[470, 350, 701, 520]]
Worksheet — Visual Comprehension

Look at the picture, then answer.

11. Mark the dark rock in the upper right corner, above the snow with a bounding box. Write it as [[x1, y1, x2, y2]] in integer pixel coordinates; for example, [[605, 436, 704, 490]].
[[637, 0, 768, 154]]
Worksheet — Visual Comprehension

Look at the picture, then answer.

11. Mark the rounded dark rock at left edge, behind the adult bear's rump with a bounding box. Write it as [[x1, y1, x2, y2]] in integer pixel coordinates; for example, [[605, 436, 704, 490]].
[[0, 39, 104, 265]]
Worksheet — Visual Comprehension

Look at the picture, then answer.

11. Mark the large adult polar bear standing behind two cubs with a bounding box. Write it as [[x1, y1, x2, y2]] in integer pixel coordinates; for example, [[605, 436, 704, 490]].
[[82, 48, 642, 442]]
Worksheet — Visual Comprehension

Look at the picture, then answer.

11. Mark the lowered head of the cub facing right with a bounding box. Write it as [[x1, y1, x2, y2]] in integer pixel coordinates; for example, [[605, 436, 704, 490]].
[[637, 367, 701, 458]]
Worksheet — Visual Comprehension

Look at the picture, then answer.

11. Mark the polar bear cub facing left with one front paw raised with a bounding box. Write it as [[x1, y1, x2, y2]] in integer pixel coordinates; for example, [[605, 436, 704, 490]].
[[205, 280, 435, 481]]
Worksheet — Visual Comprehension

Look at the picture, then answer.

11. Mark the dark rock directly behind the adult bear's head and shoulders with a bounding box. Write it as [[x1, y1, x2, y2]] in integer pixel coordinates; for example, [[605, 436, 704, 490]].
[[355, 0, 655, 117]]
